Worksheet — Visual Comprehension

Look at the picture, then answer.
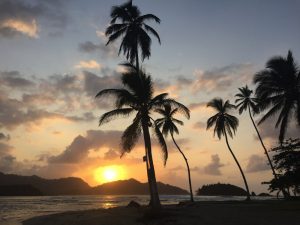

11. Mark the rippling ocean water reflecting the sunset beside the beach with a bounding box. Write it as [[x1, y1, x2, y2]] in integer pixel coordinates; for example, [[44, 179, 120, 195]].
[[0, 195, 275, 225]]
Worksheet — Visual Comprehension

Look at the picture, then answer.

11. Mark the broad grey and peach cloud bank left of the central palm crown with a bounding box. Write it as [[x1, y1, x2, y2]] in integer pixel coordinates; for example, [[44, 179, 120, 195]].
[[0, 68, 121, 129]]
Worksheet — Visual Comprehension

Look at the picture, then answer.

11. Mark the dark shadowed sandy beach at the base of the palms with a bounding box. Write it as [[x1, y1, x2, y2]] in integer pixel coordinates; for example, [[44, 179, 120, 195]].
[[23, 201, 300, 225]]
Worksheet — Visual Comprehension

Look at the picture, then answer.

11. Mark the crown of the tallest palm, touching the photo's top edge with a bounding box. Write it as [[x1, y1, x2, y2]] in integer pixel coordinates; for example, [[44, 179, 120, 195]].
[[105, 1, 160, 69]]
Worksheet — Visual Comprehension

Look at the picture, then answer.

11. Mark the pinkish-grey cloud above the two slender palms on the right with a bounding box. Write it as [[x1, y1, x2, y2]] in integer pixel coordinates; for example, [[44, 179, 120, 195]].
[[193, 64, 254, 92]]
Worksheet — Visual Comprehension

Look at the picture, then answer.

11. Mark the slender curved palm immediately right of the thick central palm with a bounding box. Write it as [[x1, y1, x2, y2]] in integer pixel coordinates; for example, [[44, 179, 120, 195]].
[[155, 105, 194, 202]]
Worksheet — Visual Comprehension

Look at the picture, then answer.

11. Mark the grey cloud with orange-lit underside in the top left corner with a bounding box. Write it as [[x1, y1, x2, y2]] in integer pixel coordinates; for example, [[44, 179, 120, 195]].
[[0, 0, 67, 38]]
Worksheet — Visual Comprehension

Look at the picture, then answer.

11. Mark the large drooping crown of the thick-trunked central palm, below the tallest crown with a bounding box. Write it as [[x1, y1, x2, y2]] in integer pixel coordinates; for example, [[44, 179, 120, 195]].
[[96, 64, 185, 163]]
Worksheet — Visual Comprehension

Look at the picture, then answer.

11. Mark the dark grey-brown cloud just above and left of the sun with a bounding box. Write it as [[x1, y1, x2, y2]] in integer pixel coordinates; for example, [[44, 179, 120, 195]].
[[48, 130, 122, 163]]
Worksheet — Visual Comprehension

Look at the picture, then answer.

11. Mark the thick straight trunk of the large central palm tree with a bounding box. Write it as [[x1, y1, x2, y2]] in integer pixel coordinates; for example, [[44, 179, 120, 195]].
[[142, 120, 161, 210]]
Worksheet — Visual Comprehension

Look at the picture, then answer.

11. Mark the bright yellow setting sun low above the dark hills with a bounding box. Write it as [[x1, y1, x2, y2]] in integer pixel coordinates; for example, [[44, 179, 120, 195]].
[[94, 166, 125, 183]]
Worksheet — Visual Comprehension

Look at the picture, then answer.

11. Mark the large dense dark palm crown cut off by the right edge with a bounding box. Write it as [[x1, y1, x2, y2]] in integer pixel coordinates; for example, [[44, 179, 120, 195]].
[[254, 51, 300, 143]]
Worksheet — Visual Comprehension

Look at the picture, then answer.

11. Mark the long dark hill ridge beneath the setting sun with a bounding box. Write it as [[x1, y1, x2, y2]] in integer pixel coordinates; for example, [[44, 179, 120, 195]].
[[0, 172, 188, 196]]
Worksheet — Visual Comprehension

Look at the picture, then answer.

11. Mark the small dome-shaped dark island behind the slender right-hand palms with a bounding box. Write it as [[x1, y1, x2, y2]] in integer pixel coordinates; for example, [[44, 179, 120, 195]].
[[197, 183, 247, 196]]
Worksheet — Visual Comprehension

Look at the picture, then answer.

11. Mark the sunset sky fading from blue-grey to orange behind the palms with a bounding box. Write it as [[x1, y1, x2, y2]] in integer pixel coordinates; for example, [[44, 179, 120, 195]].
[[0, 0, 300, 192]]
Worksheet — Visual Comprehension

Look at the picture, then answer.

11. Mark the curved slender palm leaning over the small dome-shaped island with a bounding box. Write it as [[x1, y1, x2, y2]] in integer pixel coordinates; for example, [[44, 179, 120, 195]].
[[206, 98, 250, 200]]
